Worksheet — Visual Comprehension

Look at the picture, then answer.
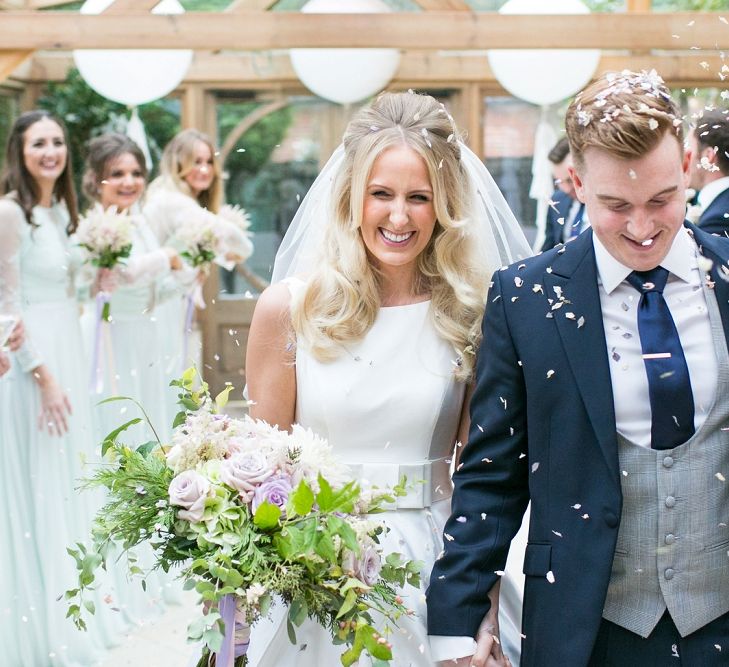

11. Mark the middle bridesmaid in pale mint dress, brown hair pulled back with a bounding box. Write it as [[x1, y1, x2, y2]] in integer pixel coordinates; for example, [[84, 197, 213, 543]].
[[81, 133, 195, 624]]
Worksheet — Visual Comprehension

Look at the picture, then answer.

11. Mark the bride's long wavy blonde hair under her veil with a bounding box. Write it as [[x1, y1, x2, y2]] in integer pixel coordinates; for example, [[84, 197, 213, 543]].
[[291, 93, 489, 381]]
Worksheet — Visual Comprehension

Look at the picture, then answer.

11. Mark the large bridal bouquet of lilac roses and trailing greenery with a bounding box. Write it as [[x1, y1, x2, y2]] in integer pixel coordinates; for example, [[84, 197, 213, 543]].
[[66, 370, 421, 667]]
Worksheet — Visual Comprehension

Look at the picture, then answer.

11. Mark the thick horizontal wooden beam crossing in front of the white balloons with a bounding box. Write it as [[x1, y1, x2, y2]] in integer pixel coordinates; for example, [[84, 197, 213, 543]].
[[0, 11, 729, 50]]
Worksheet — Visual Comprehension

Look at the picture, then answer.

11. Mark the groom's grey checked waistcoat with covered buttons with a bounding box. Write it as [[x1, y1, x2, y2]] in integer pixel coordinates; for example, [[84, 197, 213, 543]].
[[603, 276, 729, 637]]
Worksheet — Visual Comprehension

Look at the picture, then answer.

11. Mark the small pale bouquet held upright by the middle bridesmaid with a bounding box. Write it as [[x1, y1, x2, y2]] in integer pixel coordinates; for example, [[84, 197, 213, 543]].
[[76, 206, 132, 322]]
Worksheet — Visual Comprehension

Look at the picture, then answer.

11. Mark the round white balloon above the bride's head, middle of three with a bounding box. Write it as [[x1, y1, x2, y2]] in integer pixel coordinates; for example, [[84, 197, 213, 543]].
[[290, 0, 400, 104]]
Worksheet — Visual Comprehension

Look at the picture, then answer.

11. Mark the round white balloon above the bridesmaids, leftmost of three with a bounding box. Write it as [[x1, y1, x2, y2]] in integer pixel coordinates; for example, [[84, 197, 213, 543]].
[[73, 0, 192, 106]]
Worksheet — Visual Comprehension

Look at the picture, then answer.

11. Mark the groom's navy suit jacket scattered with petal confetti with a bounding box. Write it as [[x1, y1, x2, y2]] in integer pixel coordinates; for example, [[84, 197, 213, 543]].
[[427, 225, 729, 667]]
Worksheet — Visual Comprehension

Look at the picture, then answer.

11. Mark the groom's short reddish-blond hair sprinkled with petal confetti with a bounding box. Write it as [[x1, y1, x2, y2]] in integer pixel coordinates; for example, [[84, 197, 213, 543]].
[[565, 70, 683, 172]]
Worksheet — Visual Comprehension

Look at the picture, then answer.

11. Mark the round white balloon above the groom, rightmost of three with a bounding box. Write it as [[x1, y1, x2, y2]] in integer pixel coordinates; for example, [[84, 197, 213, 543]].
[[488, 0, 600, 105]]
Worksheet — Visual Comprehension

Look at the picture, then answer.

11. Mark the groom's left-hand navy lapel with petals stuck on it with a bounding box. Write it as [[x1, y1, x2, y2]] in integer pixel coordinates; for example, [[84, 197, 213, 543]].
[[544, 230, 620, 484]]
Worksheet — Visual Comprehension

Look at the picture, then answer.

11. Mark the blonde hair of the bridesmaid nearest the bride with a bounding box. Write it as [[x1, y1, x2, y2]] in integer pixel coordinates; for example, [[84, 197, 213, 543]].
[[150, 129, 223, 213]]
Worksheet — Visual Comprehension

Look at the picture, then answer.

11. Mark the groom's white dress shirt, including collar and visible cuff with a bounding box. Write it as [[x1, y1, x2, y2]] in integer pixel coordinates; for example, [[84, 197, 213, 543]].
[[430, 227, 718, 660]]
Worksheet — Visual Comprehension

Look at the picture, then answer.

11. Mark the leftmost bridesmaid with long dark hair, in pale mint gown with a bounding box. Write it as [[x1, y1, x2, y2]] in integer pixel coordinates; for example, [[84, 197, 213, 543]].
[[0, 111, 120, 667]]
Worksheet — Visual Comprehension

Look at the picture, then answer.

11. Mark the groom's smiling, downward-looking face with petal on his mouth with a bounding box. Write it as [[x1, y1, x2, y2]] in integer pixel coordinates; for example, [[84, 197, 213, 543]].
[[571, 133, 690, 271]]
